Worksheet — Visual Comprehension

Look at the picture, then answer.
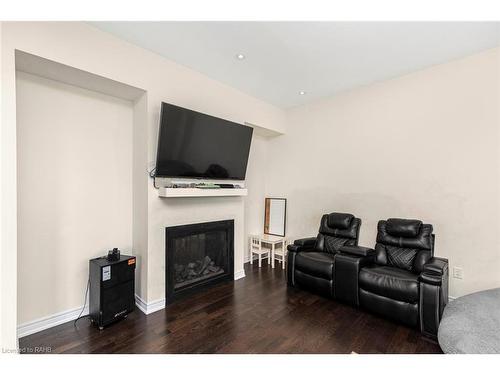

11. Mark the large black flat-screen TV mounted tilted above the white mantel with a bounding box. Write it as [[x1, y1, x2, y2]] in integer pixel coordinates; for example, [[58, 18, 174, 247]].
[[156, 103, 253, 180]]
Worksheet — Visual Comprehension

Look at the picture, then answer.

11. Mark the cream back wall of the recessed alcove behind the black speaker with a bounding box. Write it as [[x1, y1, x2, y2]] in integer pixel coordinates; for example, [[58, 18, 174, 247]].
[[17, 72, 132, 324]]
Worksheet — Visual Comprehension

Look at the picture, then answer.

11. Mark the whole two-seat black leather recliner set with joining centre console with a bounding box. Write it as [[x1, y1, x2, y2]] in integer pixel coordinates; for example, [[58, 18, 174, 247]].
[[287, 214, 448, 338]]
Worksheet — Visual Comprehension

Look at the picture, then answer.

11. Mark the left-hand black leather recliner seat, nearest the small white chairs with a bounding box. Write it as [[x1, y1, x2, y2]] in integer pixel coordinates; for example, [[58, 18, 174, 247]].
[[287, 212, 361, 297]]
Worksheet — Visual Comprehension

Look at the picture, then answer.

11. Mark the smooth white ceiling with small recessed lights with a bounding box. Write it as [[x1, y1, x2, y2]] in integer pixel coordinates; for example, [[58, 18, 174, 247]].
[[92, 22, 500, 108]]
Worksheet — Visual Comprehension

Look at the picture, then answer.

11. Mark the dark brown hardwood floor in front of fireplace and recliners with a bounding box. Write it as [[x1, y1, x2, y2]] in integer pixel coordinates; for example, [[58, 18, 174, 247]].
[[19, 264, 441, 353]]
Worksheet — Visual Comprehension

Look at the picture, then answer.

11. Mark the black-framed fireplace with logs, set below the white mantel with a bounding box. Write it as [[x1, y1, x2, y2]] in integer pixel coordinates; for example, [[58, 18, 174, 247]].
[[165, 220, 234, 305]]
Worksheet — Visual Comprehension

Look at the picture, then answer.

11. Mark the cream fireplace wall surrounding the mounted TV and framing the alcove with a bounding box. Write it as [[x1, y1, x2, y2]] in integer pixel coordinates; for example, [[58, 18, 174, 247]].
[[1, 22, 285, 346]]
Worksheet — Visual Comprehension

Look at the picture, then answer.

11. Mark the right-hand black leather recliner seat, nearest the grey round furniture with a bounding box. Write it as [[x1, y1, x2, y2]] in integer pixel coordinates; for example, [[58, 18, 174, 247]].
[[359, 219, 448, 336]]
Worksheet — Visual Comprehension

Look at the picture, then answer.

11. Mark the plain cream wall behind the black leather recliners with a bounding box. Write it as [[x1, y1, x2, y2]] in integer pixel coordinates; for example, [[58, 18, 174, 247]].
[[267, 49, 500, 297]]
